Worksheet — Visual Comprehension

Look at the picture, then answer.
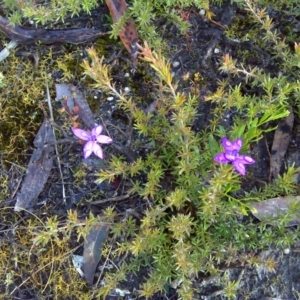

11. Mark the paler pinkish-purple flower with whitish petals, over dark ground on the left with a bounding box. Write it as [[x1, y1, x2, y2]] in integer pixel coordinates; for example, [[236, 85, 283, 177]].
[[72, 125, 112, 159]]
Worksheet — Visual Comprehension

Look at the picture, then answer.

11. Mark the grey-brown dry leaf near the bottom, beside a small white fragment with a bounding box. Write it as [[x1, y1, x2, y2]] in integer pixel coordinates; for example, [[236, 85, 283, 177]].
[[83, 223, 108, 285]]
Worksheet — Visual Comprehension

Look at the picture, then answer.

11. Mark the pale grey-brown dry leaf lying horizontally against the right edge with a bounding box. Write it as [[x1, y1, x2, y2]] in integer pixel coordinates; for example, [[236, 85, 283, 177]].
[[250, 196, 300, 226]]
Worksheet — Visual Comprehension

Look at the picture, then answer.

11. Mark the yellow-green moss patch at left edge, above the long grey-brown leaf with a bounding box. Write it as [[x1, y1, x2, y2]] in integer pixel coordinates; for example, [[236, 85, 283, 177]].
[[0, 47, 82, 164]]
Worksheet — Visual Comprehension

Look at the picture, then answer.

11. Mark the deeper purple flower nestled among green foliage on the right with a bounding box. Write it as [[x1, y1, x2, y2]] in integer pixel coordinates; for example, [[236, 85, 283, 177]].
[[214, 137, 255, 175]]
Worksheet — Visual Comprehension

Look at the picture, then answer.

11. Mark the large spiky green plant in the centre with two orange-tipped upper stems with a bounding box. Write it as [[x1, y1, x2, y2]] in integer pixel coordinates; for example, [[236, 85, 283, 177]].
[[79, 29, 298, 299]]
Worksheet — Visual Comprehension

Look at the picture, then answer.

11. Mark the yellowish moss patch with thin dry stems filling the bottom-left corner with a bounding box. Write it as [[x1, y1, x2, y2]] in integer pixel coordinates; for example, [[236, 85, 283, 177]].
[[0, 209, 93, 300]]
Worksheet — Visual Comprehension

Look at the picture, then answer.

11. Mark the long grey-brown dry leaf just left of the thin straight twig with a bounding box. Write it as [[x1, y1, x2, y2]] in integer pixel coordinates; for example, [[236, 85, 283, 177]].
[[14, 119, 54, 211]]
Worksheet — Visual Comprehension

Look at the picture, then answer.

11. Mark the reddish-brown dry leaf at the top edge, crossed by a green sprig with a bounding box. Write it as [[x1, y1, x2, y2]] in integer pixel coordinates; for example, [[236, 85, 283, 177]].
[[105, 0, 139, 58]]
